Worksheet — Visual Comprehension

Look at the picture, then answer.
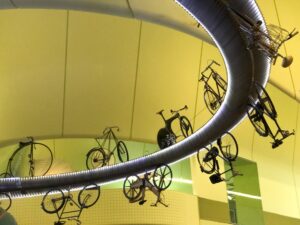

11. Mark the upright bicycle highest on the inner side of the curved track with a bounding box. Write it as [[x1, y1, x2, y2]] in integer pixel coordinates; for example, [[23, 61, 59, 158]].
[[199, 60, 227, 114]]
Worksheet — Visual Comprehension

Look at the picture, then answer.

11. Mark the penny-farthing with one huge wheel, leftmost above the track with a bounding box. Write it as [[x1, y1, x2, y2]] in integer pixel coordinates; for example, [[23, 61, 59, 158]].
[[5, 137, 53, 177]]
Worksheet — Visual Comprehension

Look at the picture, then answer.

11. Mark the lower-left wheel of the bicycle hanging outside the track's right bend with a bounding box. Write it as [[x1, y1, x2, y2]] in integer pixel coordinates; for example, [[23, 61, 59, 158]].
[[247, 104, 269, 137]]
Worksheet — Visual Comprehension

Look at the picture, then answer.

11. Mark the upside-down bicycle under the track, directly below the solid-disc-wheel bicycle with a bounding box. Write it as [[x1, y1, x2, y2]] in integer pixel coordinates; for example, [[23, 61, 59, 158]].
[[123, 165, 173, 207]]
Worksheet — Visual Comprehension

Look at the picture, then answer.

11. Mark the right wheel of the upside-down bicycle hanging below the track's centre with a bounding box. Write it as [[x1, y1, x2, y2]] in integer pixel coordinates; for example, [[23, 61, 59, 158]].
[[153, 165, 173, 190]]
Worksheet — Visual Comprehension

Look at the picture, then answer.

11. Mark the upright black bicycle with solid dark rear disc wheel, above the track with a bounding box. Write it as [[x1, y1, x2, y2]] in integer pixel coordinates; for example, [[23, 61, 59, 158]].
[[157, 105, 193, 149]]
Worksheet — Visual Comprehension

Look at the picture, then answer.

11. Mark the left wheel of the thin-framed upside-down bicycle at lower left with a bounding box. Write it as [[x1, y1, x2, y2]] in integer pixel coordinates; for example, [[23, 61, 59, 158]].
[[41, 189, 65, 214]]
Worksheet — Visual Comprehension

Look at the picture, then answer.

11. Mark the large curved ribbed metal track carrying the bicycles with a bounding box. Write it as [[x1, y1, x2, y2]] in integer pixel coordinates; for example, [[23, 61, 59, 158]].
[[0, 0, 270, 192]]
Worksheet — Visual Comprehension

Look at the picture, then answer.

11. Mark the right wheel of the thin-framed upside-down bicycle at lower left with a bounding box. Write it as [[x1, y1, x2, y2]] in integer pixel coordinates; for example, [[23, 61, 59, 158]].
[[78, 184, 100, 208]]
